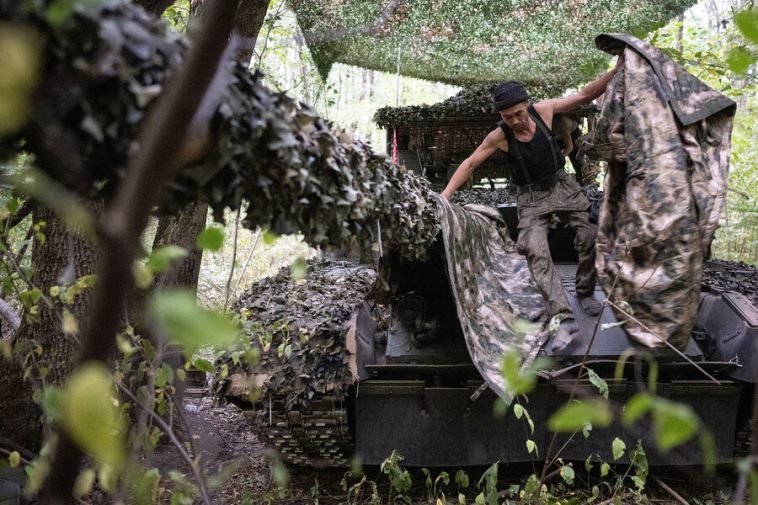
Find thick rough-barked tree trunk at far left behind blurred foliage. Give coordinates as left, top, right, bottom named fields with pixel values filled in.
left=0, top=204, right=99, bottom=450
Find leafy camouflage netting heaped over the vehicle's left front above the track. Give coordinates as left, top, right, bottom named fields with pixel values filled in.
left=224, top=260, right=376, bottom=405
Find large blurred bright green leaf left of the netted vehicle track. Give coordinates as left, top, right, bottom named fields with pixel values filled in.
left=149, top=291, right=239, bottom=355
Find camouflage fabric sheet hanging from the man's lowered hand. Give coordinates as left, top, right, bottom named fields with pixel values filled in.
left=437, top=198, right=547, bottom=402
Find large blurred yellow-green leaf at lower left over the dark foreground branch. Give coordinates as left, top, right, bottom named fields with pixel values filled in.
left=61, top=361, right=126, bottom=474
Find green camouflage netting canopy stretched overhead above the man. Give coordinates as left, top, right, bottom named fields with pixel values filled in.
left=290, top=0, right=695, bottom=88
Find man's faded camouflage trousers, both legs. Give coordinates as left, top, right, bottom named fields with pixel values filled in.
left=516, top=210, right=597, bottom=318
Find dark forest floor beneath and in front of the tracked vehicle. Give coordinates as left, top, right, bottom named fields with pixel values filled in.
left=145, top=397, right=736, bottom=505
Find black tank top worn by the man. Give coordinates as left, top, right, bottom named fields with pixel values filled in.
left=497, top=105, right=563, bottom=186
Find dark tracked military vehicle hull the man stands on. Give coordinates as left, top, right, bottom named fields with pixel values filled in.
left=226, top=191, right=758, bottom=466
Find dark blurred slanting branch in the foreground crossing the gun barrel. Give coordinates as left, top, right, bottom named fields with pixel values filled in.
left=43, top=0, right=237, bottom=505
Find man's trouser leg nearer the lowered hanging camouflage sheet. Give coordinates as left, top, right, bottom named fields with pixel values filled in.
left=516, top=214, right=573, bottom=318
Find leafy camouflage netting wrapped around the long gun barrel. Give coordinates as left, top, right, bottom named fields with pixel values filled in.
left=0, top=1, right=439, bottom=258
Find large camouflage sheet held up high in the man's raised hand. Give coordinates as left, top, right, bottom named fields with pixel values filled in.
left=590, top=34, right=735, bottom=348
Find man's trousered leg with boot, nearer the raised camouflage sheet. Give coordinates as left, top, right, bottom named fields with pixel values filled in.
left=560, top=211, right=602, bottom=316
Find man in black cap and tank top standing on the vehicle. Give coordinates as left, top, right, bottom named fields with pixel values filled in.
left=442, top=56, right=623, bottom=350
